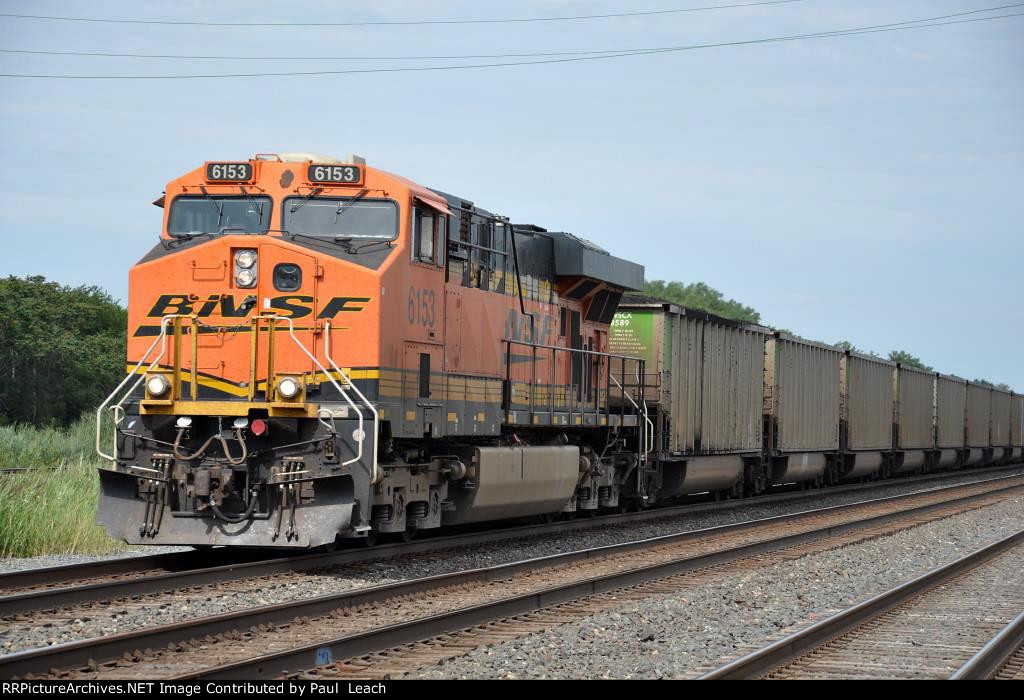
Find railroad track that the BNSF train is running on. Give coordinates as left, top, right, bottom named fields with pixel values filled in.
left=0, top=465, right=1020, bottom=620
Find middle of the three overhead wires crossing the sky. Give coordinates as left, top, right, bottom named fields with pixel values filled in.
left=0, top=2, right=1024, bottom=61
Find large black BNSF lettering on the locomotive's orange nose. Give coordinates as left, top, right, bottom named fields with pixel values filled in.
left=146, top=294, right=370, bottom=318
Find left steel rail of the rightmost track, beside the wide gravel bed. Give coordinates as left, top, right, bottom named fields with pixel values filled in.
left=700, top=530, right=1024, bottom=681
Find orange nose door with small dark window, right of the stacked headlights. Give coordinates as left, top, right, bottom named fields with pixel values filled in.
left=256, top=243, right=323, bottom=390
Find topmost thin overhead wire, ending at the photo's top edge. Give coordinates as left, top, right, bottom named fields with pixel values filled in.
left=0, top=0, right=805, bottom=27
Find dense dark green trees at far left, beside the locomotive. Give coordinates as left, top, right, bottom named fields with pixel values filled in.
left=0, top=276, right=127, bottom=426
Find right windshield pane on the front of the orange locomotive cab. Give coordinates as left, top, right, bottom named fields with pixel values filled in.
left=282, top=196, right=398, bottom=240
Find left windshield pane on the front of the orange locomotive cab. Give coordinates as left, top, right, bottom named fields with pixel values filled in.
left=167, top=194, right=270, bottom=236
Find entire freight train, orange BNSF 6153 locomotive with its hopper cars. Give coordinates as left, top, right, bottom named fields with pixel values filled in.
left=96, top=154, right=1024, bottom=548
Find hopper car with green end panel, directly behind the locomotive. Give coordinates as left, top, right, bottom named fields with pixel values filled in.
left=610, top=297, right=767, bottom=497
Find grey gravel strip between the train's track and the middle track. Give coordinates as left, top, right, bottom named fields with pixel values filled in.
left=0, top=469, right=1024, bottom=654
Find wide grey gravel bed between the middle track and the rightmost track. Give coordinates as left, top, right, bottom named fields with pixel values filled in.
left=407, top=496, right=1024, bottom=679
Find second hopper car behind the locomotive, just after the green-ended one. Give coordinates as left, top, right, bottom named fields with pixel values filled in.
left=764, top=333, right=843, bottom=483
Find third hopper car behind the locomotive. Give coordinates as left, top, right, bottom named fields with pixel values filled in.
left=839, top=352, right=896, bottom=479
